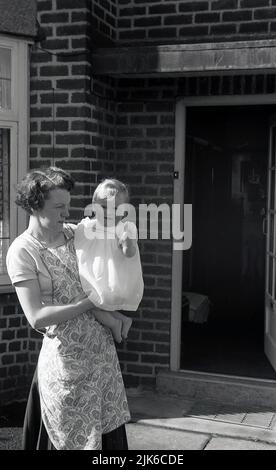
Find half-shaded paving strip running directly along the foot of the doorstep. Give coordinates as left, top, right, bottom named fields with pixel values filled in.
left=128, top=392, right=276, bottom=444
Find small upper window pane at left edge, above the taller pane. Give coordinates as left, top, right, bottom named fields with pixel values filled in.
left=0, top=47, right=11, bottom=109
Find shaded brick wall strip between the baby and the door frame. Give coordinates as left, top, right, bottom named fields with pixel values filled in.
left=116, top=79, right=177, bottom=387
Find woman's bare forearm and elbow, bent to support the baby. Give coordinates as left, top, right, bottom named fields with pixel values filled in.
left=14, top=279, right=93, bottom=328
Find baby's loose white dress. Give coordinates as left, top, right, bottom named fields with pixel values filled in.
left=75, top=217, right=144, bottom=311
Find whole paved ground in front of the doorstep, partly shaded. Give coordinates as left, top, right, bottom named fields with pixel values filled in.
left=0, top=389, right=276, bottom=451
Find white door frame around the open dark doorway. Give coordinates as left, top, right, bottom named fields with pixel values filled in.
left=170, top=93, right=276, bottom=371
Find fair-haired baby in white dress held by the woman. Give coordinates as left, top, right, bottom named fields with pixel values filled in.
left=75, top=179, right=144, bottom=343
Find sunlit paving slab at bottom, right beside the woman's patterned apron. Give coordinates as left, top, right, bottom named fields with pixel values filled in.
left=126, top=423, right=210, bottom=450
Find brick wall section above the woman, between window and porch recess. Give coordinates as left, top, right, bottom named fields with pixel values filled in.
left=30, top=0, right=115, bottom=220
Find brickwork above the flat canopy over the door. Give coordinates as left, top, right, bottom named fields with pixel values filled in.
left=117, top=0, right=276, bottom=44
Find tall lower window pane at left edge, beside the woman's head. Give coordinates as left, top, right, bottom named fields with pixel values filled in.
left=0, top=128, right=10, bottom=274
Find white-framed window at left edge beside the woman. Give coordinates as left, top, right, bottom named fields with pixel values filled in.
left=0, top=36, right=29, bottom=292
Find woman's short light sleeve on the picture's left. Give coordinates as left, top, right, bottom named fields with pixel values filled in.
left=6, top=243, right=37, bottom=284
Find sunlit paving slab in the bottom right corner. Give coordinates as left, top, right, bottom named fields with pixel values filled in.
left=204, top=437, right=276, bottom=450
